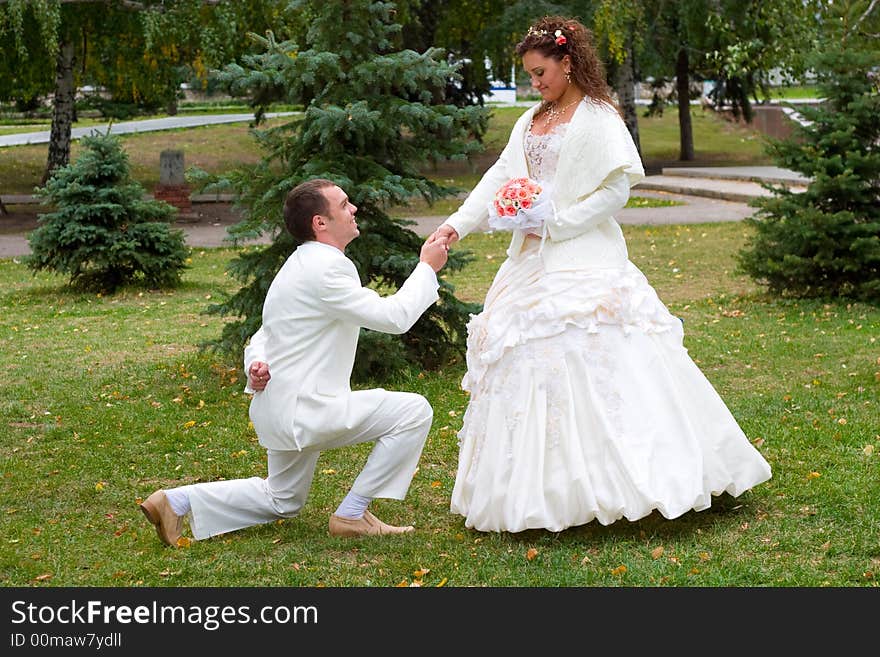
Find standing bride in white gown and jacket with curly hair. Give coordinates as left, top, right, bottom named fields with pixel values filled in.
left=435, top=17, right=771, bottom=532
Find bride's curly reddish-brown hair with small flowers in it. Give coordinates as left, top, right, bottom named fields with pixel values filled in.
left=516, top=16, right=619, bottom=114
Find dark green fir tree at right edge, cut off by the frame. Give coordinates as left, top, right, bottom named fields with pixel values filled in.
left=739, top=48, right=880, bottom=303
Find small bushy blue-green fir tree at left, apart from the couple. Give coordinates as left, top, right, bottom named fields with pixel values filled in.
left=25, top=133, right=189, bottom=292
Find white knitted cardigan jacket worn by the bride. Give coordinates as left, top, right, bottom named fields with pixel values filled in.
left=445, top=101, right=645, bottom=271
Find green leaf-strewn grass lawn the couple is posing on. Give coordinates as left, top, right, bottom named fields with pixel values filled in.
left=0, top=223, right=880, bottom=587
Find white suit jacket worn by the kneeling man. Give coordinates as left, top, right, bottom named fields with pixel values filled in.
left=245, top=241, right=439, bottom=450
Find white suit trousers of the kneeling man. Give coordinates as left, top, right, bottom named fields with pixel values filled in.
left=181, top=389, right=433, bottom=539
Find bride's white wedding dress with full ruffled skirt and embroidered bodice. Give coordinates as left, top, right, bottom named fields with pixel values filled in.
left=451, top=125, right=771, bottom=532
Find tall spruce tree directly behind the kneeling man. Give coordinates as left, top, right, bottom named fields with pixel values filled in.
left=200, top=0, right=487, bottom=379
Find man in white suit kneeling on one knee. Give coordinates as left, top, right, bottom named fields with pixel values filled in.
left=141, top=179, right=447, bottom=546
